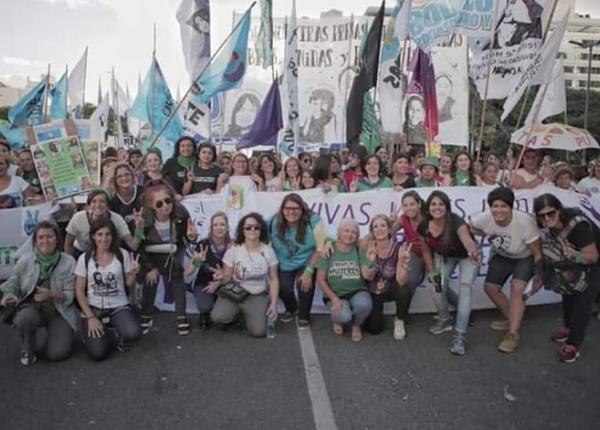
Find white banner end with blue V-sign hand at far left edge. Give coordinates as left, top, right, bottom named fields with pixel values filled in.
left=0, top=203, right=58, bottom=279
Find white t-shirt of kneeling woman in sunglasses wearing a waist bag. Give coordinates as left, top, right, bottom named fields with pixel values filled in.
left=223, top=244, right=277, bottom=294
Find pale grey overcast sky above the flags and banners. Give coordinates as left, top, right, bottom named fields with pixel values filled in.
left=0, top=0, right=600, bottom=103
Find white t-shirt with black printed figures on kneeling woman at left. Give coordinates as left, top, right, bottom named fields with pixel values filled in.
left=75, top=248, right=131, bottom=309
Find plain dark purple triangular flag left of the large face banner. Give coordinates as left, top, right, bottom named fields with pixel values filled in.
left=235, top=80, right=283, bottom=149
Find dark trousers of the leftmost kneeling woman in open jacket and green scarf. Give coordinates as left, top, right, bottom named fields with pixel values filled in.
left=14, top=306, right=73, bottom=361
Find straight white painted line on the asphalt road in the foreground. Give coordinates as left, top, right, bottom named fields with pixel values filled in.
left=298, top=328, right=337, bottom=430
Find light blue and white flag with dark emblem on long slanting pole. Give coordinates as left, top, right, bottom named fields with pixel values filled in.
left=196, top=10, right=250, bottom=103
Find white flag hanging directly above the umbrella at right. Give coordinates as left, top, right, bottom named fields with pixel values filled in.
left=525, top=59, right=567, bottom=124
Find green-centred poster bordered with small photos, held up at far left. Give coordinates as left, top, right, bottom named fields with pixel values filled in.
left=28, top=121, right=92, bottom=200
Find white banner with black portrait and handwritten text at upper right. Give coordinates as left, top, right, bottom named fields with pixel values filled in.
left=469, top=0, right=554, bottom=99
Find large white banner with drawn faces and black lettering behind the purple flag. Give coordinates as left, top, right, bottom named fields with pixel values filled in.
left=223, top=13, right=368, bottom=148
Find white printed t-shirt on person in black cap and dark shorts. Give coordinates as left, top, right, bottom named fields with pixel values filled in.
left=471, top=210, right=540, bottom=259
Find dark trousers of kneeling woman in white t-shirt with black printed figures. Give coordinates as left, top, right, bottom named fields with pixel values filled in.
left=82, top=306, right=142, bottom=361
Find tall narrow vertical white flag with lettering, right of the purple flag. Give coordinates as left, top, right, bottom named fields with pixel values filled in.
left=283, top=0, right=300, bottom=155
